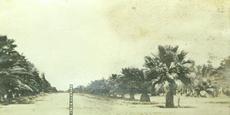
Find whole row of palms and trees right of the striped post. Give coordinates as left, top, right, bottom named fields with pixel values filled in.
left=75, top=45, right=230, bottom=107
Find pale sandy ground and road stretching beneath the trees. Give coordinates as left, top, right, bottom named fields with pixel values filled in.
left=0, top=93, right=230, bottom=115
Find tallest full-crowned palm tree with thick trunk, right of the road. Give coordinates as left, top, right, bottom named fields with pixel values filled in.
left=144, top=45, right=192, bottom=107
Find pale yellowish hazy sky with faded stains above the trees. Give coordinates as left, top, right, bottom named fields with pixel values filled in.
left=0, top=0, right=230, bottom=89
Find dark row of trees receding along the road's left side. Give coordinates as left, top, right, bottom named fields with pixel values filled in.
left=0, top=36, right=56, bottom=103
